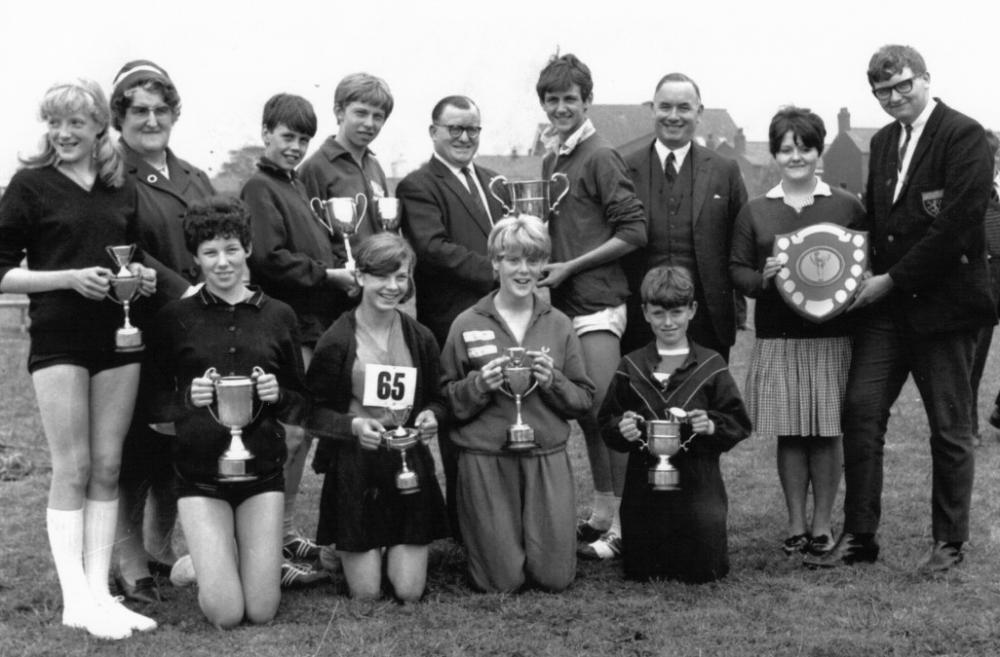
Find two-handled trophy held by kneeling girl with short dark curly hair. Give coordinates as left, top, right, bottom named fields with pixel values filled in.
left=205, top=367, right=264, bottom=481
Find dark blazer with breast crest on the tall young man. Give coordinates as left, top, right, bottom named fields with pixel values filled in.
left=866, top=101, right=996, bottom=334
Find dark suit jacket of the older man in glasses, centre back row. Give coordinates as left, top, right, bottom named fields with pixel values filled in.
left=396, top=157, right=504, bottom=345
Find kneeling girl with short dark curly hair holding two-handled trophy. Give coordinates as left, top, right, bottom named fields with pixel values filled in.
left=143, top=197, right=307, bottom=628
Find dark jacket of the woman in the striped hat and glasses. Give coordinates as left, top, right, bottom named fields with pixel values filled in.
left=121, top=140, right=215, bottom=306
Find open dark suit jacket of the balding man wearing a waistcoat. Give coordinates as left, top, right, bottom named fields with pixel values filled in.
left=622, top=142, right=747, bottom=345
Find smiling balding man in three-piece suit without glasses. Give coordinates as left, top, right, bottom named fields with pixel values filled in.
left=622, top=73, right=747, bottom=360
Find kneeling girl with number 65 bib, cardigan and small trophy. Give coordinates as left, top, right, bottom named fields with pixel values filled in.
left=306, top=233, right=448, bottom=602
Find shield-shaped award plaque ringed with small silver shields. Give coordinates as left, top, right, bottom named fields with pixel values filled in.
left=774, top=223, right=868, bottom=323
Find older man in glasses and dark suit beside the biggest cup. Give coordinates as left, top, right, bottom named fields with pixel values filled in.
left=396, top=96, right=503, bottom=345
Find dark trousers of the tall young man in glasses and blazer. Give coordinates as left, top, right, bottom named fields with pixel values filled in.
left=843, top=302, right=976, bottom=541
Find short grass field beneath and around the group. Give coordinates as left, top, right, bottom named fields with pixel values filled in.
left=0, top=322, right=1000, bottom=657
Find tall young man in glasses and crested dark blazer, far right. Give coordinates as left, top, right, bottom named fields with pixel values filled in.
left=806, top=45, right=996, bottom=572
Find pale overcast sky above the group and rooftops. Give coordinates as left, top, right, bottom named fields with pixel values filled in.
left=0, top=0, right=1000, bottom=184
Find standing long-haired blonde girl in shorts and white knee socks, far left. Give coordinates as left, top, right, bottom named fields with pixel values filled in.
left=0, top=80, right=156, bottom=639
